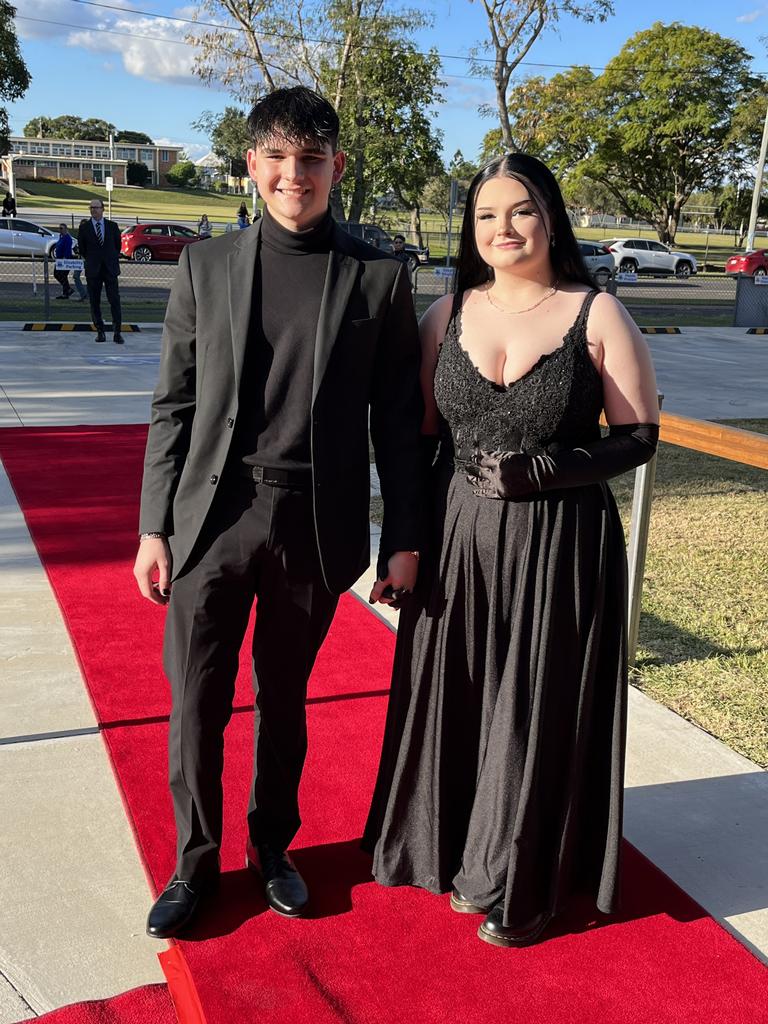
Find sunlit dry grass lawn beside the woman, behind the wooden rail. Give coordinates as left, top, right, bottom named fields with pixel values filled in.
left=372, top=420, right=768, bottom=767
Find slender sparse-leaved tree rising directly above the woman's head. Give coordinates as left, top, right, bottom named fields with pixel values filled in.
left=470, top=0, right=613, bottom=153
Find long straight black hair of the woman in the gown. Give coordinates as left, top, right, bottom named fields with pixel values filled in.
left=454, top=153, right=596, bottom=292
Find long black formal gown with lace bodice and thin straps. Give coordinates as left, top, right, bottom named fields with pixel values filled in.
left=364, top=293, right=627, bottom=926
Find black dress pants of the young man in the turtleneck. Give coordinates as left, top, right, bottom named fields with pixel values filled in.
left=164, top=479, right=338, bottom=881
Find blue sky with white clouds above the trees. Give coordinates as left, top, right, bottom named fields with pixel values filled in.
left=9, top=0, right=768, bottom=158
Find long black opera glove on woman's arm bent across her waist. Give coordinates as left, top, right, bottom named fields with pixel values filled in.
left=467, top=423, right=658, bottom=501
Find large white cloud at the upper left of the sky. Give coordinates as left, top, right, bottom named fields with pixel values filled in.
left=17, top=0, right=210, bottom=85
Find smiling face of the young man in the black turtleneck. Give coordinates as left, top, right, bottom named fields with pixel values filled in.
left=248, top=137, right=345, bottom=231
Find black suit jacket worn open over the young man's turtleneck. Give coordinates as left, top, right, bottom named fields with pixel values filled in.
left=139, top=222, right=424, bottom=594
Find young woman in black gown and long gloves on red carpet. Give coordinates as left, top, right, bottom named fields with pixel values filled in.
left=366, top=155, right=658, bottom=946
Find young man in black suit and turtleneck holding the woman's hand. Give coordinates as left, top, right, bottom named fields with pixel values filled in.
left=134, top=87, right=423, bottom=938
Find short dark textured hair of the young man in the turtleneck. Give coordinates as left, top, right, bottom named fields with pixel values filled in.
left=248, top=85, right=339, bottom=153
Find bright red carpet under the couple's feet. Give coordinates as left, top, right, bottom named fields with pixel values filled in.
left=0, top=417, right=768, bottom=1024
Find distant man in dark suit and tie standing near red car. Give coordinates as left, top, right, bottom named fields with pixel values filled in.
left=78, top=199, right=124, bottom=345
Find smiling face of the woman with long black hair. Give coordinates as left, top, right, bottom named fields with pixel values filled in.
left=474, top=176, right=551, bottom=275
